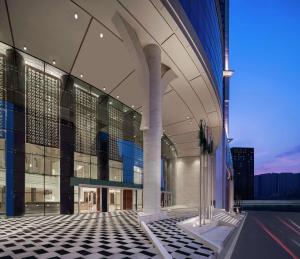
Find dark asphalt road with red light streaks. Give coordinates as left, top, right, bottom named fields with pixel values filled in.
left=231, top=211, right=300, bottom=259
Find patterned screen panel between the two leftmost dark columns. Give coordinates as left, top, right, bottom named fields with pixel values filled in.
left=26, top=65, right=60, bottom=147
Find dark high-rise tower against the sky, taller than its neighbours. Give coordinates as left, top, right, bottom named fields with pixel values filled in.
left=231, top=147, right=254, bottom=200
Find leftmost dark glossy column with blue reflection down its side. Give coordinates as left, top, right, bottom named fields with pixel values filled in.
left=5, top=49, right=25, bottom=216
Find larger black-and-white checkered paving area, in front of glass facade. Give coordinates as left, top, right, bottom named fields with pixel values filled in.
left=0, top=211, right=160, bottom=259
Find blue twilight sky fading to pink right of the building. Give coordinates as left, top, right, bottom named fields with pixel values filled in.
left=230, top=0, right=300, bottom=174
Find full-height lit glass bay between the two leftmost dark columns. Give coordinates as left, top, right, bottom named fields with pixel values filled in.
left=25, top=61, right=60, bottom=214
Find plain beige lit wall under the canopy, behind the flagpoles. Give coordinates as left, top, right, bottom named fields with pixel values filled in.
left=173, top=157, right=200, bottom=207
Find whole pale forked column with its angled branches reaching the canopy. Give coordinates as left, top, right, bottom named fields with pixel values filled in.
left=112, top=12, right=176, bottom=217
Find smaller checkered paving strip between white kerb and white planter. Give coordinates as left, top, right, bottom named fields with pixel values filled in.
left=148, top=215, right=214, bottom=259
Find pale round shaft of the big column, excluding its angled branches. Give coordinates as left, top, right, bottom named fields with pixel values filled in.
left=143, top=44, right=162, bottom=214
